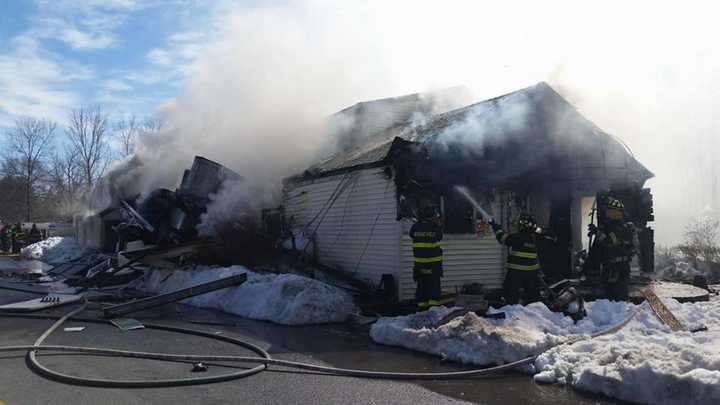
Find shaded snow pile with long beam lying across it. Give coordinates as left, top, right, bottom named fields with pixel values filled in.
left=139, top=266, right=358, bottom=325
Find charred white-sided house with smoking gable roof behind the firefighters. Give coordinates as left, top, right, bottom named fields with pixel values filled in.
left=283, top=83, right=653, bottom=300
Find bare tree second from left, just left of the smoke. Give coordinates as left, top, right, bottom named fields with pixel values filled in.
left=68, top=107, right=110, bottom=189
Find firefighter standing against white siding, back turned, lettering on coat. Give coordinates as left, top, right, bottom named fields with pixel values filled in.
left=410, top=206, right=443, bottom=309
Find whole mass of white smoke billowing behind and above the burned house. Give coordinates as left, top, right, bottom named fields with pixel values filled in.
left=100, top=0, right=720, bottom=243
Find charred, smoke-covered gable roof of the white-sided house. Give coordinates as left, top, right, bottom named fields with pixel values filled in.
left=301, top=82, right=653, bottom=191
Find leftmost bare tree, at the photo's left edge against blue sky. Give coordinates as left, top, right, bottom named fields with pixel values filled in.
left=5, top=117, right=57, bottom=222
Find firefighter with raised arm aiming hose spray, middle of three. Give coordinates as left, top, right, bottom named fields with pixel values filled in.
left=490, top=214, right=541, bottom=304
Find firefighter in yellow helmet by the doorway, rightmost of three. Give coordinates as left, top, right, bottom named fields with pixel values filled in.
left=588, top=197, right=635, bottom=301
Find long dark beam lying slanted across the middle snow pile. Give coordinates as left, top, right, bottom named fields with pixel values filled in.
left=103, top=273, right=247, bottom=318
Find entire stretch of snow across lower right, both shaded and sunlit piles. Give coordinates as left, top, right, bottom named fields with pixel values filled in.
left=370, top=299, right=720, bottom=404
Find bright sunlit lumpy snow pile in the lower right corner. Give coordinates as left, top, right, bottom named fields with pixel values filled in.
left=535, top=300, right=720, bottom=404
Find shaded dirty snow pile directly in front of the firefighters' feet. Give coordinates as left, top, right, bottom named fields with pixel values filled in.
left=370, top=300, right=631, bottom=365
